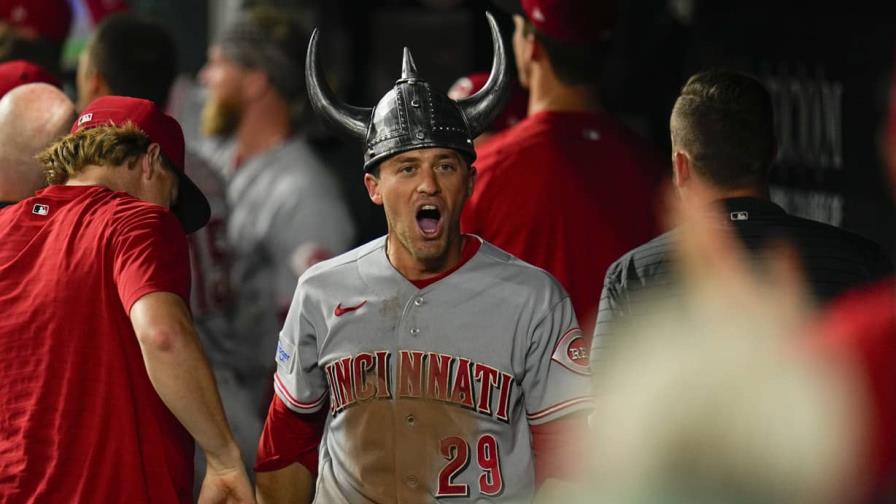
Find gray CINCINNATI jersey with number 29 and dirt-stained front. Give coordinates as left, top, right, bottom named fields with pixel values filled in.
left=274, top=237, right=591, bottom=503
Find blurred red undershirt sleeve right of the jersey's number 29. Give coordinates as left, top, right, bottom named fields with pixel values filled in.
left=529, top=413, right=588, bottom=488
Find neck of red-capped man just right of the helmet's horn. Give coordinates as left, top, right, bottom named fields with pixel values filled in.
left=529, top=68, right=601, bottom=116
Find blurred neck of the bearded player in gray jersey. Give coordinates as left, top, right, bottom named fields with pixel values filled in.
left=236, top=96, right=292, bottom=160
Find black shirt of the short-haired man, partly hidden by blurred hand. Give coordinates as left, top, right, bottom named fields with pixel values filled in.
left=592, top=198, right=892, bottom=357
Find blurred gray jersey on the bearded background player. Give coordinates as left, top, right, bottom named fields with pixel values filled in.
left=219, top=137, right=354, bottom=378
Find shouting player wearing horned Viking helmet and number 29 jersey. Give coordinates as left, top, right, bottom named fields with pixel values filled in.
left=256, top=16, right=590, bottom=503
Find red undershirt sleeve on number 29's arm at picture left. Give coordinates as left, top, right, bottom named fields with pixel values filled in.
left=255, top=395, right=327, bottom=478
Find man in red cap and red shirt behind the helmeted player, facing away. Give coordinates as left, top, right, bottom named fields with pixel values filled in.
left=462, top=0, right=667, bottom=339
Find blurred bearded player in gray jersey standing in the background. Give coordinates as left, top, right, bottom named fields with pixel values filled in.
left=200, top=5, right=355, bottom=428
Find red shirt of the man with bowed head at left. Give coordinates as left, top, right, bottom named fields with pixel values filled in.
left=0, top=186, right=193, bottom=503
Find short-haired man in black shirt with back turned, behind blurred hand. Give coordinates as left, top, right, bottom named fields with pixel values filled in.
left=593, top=70, right=892, bottom=359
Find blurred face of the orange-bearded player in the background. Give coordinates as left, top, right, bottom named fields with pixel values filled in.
left=199, top=46, right=245, bottom=136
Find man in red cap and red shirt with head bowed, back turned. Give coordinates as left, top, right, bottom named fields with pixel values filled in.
left=0, top=96, right=252, bottom=503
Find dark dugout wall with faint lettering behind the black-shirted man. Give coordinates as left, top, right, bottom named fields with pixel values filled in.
left=603, top=0, right=896, bottom=253
